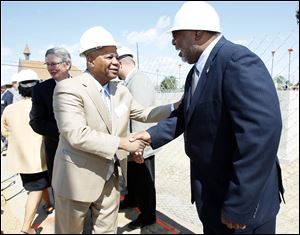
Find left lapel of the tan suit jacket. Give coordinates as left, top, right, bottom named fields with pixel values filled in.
left=82, top=73, right=112, bottom=133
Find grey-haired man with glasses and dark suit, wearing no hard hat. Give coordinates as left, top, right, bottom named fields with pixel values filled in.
left=30, top=47, right=72, bottom=182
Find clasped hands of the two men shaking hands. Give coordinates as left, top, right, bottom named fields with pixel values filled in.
left=119, top=131, right=151, bottom=163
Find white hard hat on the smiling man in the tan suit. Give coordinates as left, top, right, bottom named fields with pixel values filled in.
left=79, top=26, right=116, bottom=56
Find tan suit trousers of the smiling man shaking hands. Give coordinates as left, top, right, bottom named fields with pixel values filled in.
left=54, top=174, right=120, bottom=234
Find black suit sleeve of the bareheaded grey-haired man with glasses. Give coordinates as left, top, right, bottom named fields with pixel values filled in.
left=29, top=87, right=58, bottom=138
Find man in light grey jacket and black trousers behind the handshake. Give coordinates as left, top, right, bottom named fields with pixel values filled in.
left=117, top=46, right=156, bottom=229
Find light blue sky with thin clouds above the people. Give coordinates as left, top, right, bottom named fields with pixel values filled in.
left=1, top=1, right=299, bottom=85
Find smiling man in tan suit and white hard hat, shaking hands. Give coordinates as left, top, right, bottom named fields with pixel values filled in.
left=52, top=27, right=171, bottom=234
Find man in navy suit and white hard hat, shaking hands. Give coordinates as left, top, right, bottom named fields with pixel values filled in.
left=132, top=2, right=283, bottom=234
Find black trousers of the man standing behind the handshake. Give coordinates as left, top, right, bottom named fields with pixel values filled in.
left=124, top=155, right=156, bottom=221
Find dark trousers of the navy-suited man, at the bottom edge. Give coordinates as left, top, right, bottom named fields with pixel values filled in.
left=203, top=217, right=276, bottom=234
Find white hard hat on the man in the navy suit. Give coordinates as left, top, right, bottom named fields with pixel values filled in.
left=169, top=1, right=221, bottom=32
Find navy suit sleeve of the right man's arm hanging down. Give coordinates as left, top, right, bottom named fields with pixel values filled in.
left=222, top=49, right=282, bottom=224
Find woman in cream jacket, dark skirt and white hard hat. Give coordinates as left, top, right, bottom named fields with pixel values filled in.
left=1, top=69, right=53, bottom=234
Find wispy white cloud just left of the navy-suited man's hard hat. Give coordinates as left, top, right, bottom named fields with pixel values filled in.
left=127, top=16, right=171, bottom=49
